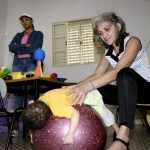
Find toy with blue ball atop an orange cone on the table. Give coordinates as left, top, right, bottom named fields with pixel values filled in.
left=34, top=48, right=45, bottom=77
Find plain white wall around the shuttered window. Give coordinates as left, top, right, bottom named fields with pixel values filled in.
left=0, top=0, right=150, bottom=82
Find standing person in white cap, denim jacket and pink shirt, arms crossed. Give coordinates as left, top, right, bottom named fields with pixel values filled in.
left=9, top=13, right=43, bottom=137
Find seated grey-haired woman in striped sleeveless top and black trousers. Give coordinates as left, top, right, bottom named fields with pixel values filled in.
left=68, top=12, right=150, bottom=150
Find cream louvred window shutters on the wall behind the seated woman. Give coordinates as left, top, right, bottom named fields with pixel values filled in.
left=53, top=19, right=104, bottom=67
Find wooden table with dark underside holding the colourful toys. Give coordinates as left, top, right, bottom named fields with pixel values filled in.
left=5, top=77, right=70, bottom=105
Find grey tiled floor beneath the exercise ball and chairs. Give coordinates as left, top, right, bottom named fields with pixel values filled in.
left=0, top=126, right=150, bottom=150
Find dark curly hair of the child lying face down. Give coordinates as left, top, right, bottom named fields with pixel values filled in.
left=22, top=100, right=51, bottom=130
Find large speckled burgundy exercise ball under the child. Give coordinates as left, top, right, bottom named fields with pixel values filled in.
left=33, top=105, right=107, bottom=150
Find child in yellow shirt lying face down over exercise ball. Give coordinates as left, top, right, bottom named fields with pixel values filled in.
left=22, top=88, right=118, bottom=144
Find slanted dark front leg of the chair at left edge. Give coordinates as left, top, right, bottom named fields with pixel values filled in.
left=5, top=112, right=16, bottom=150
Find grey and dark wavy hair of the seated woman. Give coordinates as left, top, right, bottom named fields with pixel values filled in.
left=93, top=12, right=129, bottom=47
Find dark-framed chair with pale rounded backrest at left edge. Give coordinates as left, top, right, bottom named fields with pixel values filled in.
left=0, top=78, right=25, bottom=150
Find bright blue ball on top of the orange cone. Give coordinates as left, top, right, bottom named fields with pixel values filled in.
left=34, top=48, right=45, bottom=61
